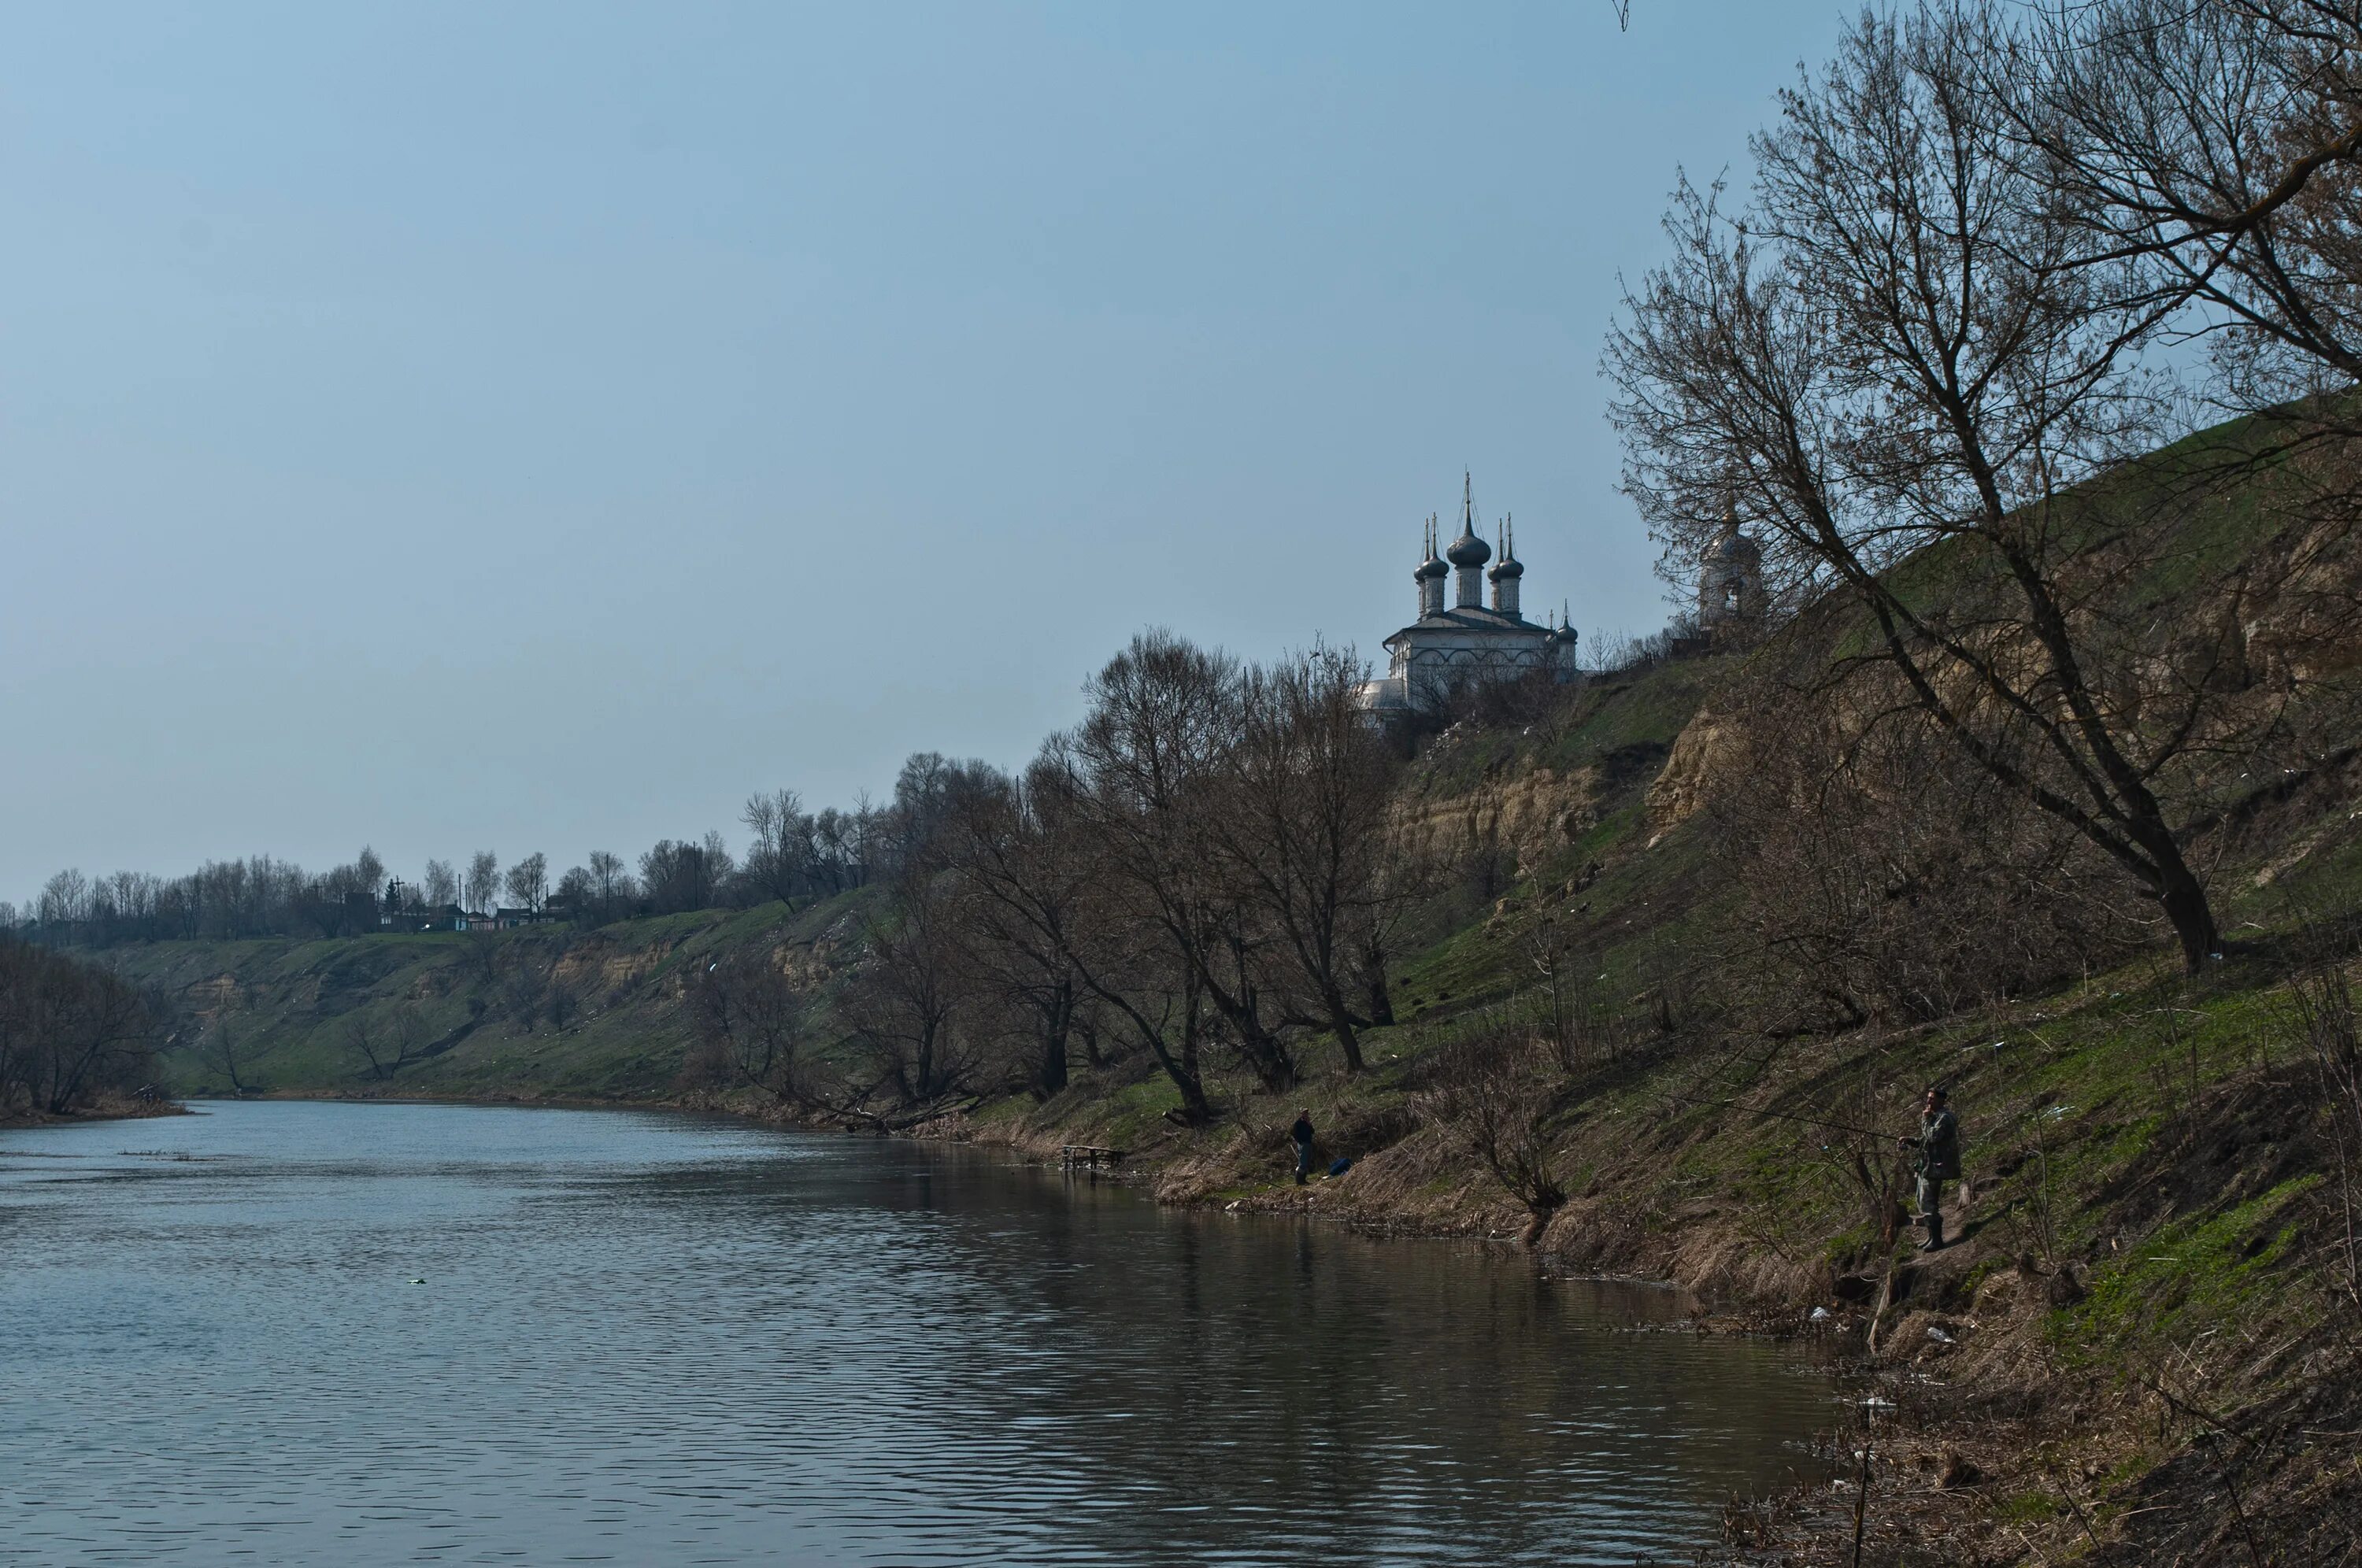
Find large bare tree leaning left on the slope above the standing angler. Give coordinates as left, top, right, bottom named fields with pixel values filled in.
left=1606, top=5, right=2220, bottom=968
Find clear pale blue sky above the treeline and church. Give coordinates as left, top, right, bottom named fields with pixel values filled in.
left=0, top=0, right=1845, bottom=897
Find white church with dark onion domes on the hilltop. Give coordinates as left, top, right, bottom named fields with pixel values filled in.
left=1361, top=475, right=1580, bottom=716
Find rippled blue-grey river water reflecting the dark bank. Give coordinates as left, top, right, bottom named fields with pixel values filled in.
left=0, top=1103, right=1831, bottom=1566
